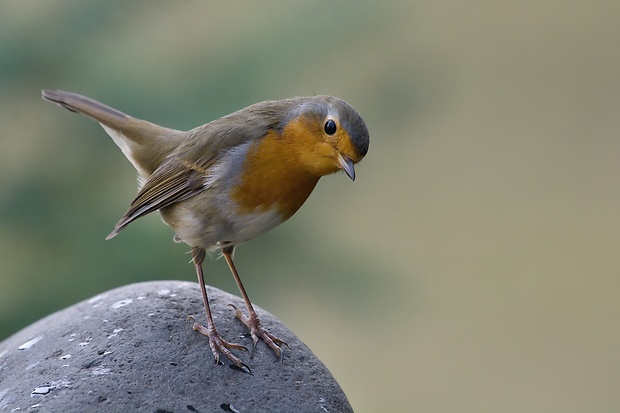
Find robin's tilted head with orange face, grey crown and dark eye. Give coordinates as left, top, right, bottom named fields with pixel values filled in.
left=282, top=96, right=369, bottom=180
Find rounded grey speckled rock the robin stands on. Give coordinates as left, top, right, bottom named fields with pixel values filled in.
left=0, top=281, right=352, bottom=413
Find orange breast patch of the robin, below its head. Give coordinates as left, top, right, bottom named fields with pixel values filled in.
left=231, top=125, right=320, bottom=219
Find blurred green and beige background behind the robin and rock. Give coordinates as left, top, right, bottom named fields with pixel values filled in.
left=0, top=0, right=620, bottom=412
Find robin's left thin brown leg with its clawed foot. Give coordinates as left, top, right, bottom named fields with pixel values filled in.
left=189, top=247, right=250, bottom=373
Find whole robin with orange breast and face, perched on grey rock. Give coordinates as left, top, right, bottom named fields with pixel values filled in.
left=42, top=90, right=369, bottom=372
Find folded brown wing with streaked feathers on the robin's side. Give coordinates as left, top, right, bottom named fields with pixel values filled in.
left=106, top=156, right=214, bottom=239
